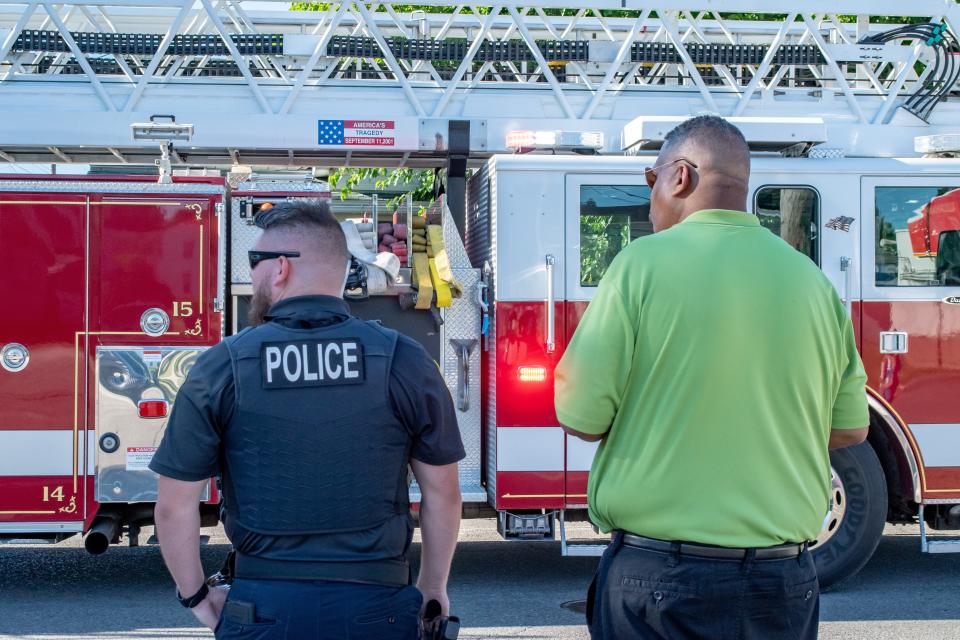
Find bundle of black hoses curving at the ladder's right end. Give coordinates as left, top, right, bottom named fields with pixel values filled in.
left=860, top=24, right=960, bottom=121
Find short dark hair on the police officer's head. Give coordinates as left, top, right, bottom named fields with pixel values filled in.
left=253, top=200, right=350, bottom=263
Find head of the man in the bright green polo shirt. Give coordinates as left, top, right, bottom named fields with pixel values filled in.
left=648, top=116, right=750, bottom=231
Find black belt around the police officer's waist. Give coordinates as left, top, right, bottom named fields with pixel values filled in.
left=234, top=553, right=410, bottom=587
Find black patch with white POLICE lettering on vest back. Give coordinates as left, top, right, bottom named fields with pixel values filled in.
left=260, top=340, right=364, bottom=389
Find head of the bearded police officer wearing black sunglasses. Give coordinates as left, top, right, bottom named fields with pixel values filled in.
left=251, top=200, right=350, bottom=303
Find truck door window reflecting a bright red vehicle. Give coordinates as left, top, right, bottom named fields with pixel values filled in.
left=874, top=187, right=960, bottom=287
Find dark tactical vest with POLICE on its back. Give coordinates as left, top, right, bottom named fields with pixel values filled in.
left=223, top=317, right=411, bottom=535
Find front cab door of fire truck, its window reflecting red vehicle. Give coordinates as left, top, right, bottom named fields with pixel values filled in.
left=861, top=175, right=960, bottom=499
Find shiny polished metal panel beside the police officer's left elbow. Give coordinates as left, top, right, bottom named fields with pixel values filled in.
left=95, top=346, right=210, bottom=503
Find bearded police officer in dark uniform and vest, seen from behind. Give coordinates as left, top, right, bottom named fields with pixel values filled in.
left=150, top=203, right=464, bottom=640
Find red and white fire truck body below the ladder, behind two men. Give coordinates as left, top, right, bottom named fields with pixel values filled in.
left=0, top=141, right=960, bottom=583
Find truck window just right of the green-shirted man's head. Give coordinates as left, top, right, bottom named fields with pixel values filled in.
left=753, top=186, right=820, bottom=262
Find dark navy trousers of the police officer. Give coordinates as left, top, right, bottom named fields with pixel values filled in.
left=214, top=579, right=423, bottom=640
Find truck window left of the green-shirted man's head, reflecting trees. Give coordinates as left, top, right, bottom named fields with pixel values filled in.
left=580, top=184, right=653, bottom=287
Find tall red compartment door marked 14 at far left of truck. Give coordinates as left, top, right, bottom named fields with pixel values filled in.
left=0, top=195, right=89, bottom=531
